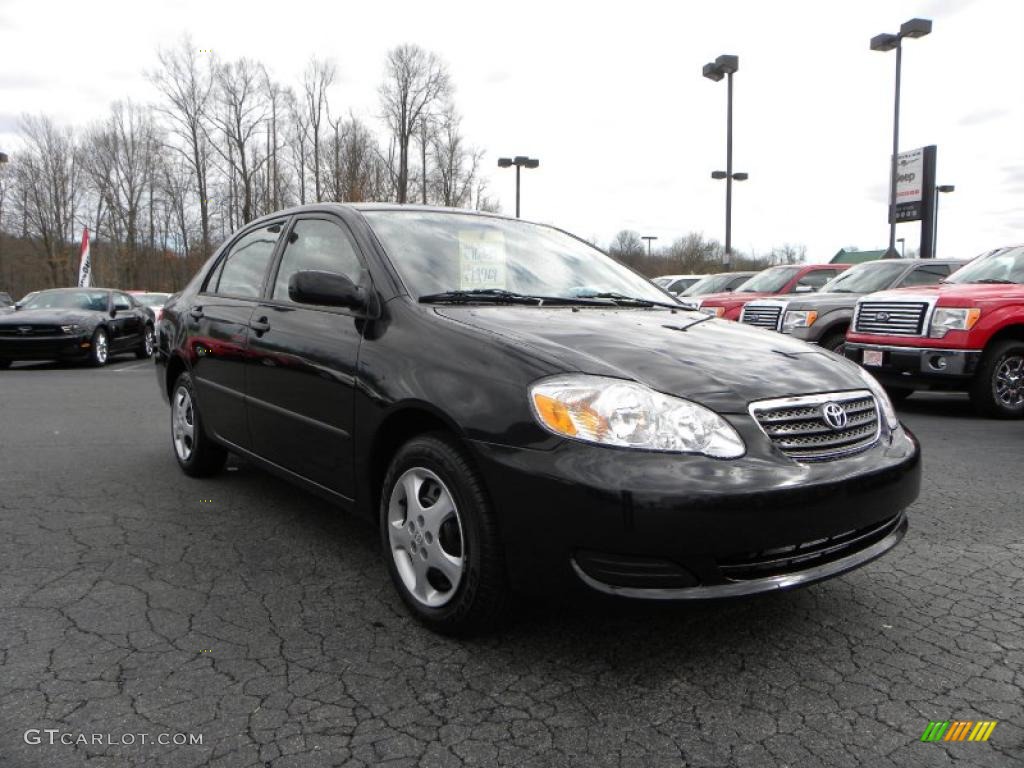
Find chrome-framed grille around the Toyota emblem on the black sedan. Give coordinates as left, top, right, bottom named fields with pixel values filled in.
left=751, top=389, right=880, bottom=461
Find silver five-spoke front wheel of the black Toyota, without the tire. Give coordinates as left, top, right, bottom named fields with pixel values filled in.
left=387, top=467, right=466, bottom=608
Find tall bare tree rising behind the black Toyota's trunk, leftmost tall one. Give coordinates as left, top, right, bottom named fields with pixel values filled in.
left=148, top=36, right=213, bottom=257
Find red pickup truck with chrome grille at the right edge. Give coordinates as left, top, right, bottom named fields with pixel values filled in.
left=845, top=246, right=1024, bottom=419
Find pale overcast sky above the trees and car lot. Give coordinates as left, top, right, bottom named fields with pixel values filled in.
left=0, top=0, right=1024, bottom=261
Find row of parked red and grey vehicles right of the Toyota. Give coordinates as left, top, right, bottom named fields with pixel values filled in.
left=663, top=247, right=1024, bottom=419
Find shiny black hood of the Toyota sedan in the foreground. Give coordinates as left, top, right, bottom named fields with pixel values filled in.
left=434, top=306, right=864, bottom=414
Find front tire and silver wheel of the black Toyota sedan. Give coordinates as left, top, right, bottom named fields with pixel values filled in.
left=380, top=433, right=509, bottom=635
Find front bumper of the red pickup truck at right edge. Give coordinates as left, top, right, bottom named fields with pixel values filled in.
left=844, top=341, right=982, bottom=389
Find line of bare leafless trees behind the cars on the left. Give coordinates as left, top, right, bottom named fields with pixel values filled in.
left=0, top=37, right=497, bottom=296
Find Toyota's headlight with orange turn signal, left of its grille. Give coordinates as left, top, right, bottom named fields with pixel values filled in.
left=529, top=374, right=746, bottom=459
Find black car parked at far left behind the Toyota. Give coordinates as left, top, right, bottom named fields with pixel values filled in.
left=0, top=288, right=155, bottom=369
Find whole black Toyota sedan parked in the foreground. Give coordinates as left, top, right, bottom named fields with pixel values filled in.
left=157, top=204, right=920, bottom=632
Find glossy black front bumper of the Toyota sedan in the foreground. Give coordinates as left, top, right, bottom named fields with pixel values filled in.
left=473, top=424, right=921, bottom=600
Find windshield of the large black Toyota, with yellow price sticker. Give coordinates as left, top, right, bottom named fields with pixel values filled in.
left=364, top=211, right=669, bottom=303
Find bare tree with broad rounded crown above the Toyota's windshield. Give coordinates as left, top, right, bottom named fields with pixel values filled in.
left=380, top=44, right=451, bottom=203
